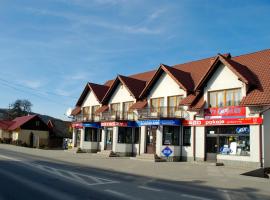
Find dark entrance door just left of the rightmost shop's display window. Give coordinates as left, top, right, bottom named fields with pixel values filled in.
left=206, top=136, right=218, bottom=162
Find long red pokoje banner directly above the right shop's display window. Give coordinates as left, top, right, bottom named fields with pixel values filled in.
left=182, top=117, right=263, bottom=126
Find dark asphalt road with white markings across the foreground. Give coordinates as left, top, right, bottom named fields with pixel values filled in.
left=0, top=149, right=270, bottom=200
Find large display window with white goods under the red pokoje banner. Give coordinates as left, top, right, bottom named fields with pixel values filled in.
left=206, top=125, right=250, bottom=156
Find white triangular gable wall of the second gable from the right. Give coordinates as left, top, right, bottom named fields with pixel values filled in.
left=147, top=72, right=186, bottom=106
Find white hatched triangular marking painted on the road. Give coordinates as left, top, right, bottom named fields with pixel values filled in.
left=33, top=165, right=119, bottom=186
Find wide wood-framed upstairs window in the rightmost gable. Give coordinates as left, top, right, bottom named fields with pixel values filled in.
left=208, top=89, right=242, bottom=107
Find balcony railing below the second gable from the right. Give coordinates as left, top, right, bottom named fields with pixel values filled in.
left=138, top=107, right=188, bottom=119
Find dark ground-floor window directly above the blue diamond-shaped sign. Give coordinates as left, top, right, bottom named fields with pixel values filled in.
left=163, top=126, right=180, bottom=146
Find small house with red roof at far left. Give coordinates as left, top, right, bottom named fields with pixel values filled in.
left=0, top=115, right=49, bottom=147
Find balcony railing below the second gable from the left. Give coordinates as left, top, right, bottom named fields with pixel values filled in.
left=101, top=111, right=136, bottom=121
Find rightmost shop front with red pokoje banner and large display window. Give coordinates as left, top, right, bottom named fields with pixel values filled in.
left=183, top=117, right=263, bottom=167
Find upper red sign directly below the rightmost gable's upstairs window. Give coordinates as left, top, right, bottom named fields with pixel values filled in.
left=204, top=106, right=246, bottom=119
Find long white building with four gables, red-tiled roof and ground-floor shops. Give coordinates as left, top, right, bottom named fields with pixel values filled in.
left=73, top=50, right=270, bottom=168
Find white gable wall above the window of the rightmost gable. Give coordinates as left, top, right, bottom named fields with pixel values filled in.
left=204, top=64, right=246, bottom=106
